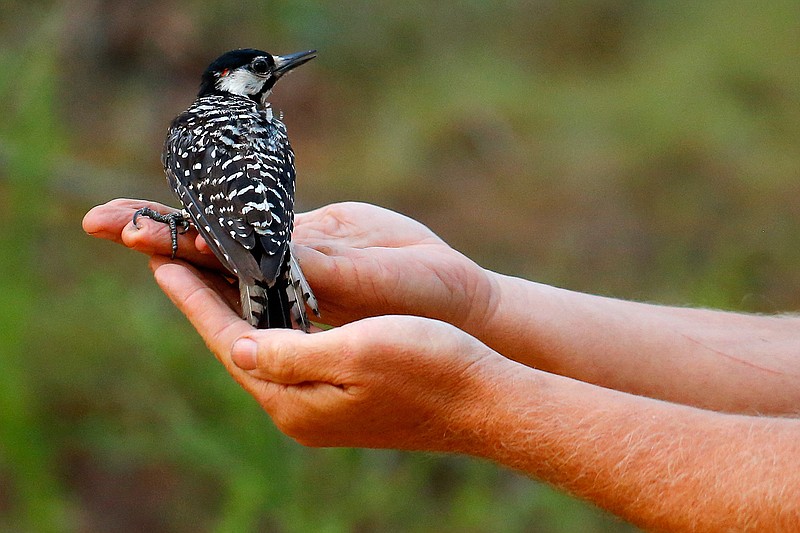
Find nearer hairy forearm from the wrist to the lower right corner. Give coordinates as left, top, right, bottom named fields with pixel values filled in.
left=464, top=369, right=800, bottom=531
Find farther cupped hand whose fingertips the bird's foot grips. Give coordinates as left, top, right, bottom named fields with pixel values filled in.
left=83, top=199, right=496, bottom=332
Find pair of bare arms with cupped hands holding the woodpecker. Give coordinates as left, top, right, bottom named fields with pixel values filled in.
left=84, top=200, right=800, bottom=531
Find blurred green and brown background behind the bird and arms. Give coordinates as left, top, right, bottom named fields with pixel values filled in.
left=0, top=0, right=800, bottom=532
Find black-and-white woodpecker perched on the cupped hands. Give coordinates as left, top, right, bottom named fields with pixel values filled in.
left=133, top=48, right=319, bottom=333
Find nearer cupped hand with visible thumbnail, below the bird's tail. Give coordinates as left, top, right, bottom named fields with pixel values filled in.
left=151, top=256, right=516, bottom=453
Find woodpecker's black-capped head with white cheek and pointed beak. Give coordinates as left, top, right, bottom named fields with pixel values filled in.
left=197, top=48, right=317, bottom=104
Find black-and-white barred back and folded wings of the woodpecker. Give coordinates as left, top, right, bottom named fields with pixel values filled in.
left=163, top=96, right=295, bottom=286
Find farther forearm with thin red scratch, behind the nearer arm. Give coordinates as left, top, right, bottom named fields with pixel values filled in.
left=471, top=274, right=800, bottom=414
